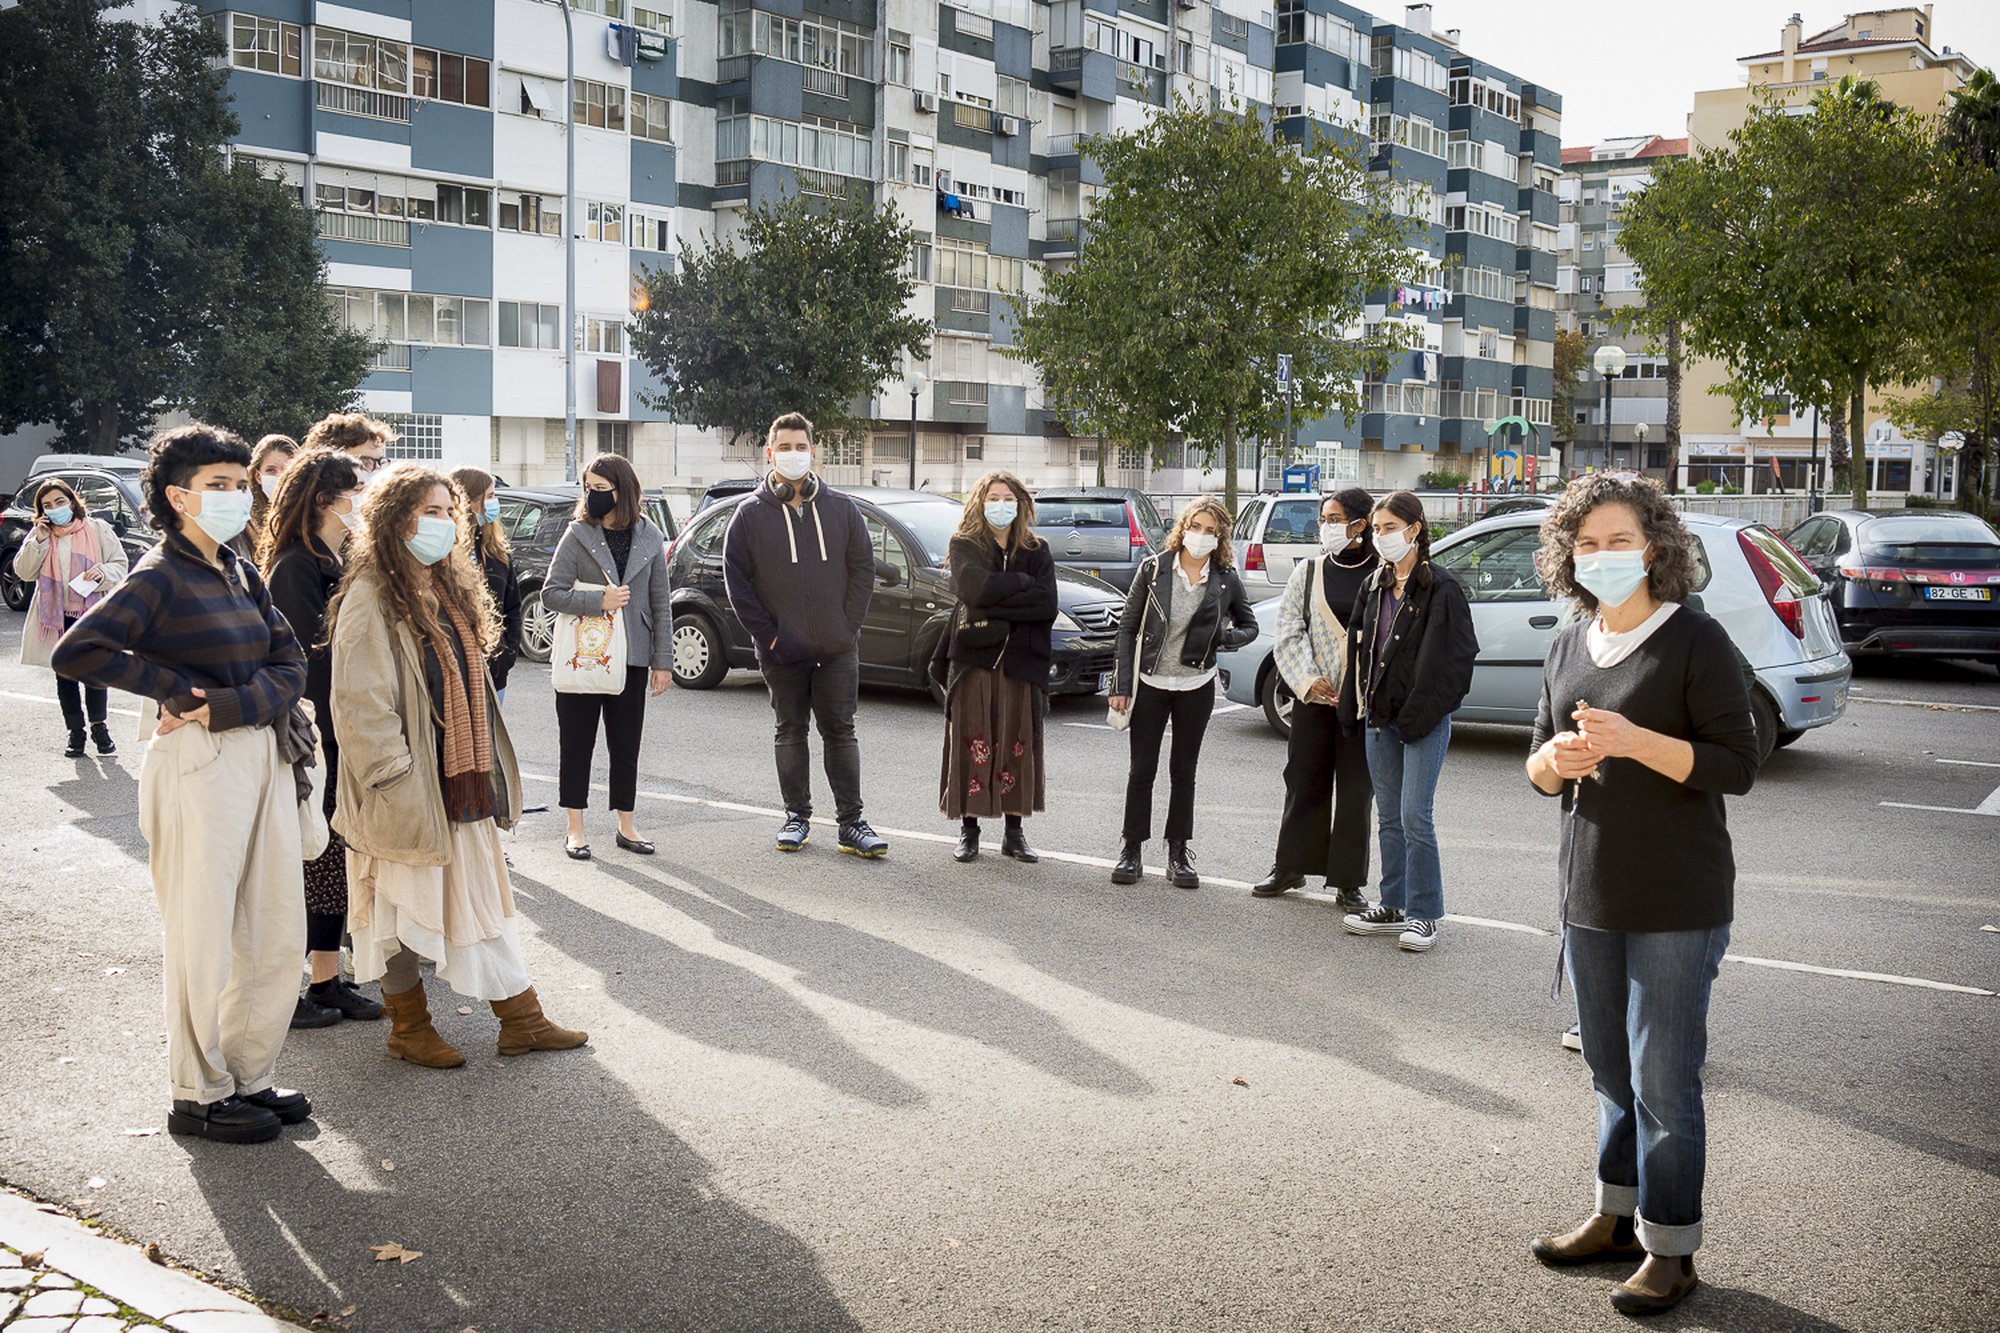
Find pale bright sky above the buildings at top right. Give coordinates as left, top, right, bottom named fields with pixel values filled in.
left=1348, top=0, right=2000, bottom=144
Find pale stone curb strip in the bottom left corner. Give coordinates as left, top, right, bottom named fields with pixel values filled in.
left=0, top=1189, right=308, bottom=1333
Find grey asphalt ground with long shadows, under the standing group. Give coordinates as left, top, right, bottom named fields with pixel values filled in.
left=0, top=614, right=2000, bottom=1333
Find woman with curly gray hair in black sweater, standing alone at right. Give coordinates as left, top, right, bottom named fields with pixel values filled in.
left=1528, top=476, right=1758, bottom=1315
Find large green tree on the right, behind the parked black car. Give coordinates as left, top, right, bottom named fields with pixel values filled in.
left=1620, top=78, right=1940, bottom=504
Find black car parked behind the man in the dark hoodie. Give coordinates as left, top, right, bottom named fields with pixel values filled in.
left=668, top=486, right=1124, bottom=695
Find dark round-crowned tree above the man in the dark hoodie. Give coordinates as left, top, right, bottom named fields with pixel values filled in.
left=632, top=196, right=930, bottom=444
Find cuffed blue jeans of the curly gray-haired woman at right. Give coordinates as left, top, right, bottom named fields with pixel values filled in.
left=1564, top=925, right=1730, bottom=1255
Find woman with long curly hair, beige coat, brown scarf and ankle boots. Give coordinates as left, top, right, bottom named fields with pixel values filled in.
left=328, top=464, right=588, bottom=1069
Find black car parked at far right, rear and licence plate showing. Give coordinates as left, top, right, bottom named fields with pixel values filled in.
left=1788, top=508, right=2000, bottom=664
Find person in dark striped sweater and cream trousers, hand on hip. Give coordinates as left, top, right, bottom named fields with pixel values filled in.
left=54, top=424, right=312, bottom=1143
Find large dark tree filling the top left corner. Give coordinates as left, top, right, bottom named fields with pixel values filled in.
left=0, top=0, right=370, bottom=452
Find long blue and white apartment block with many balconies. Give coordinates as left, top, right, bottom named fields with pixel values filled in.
left=200, top=0, right=1562, bottom=492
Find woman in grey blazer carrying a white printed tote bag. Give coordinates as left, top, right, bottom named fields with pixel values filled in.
left=542, top=454, right=674, bottom=861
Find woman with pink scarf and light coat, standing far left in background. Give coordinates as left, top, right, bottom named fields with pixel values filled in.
left=14, top=476, right=128, bottom=759
